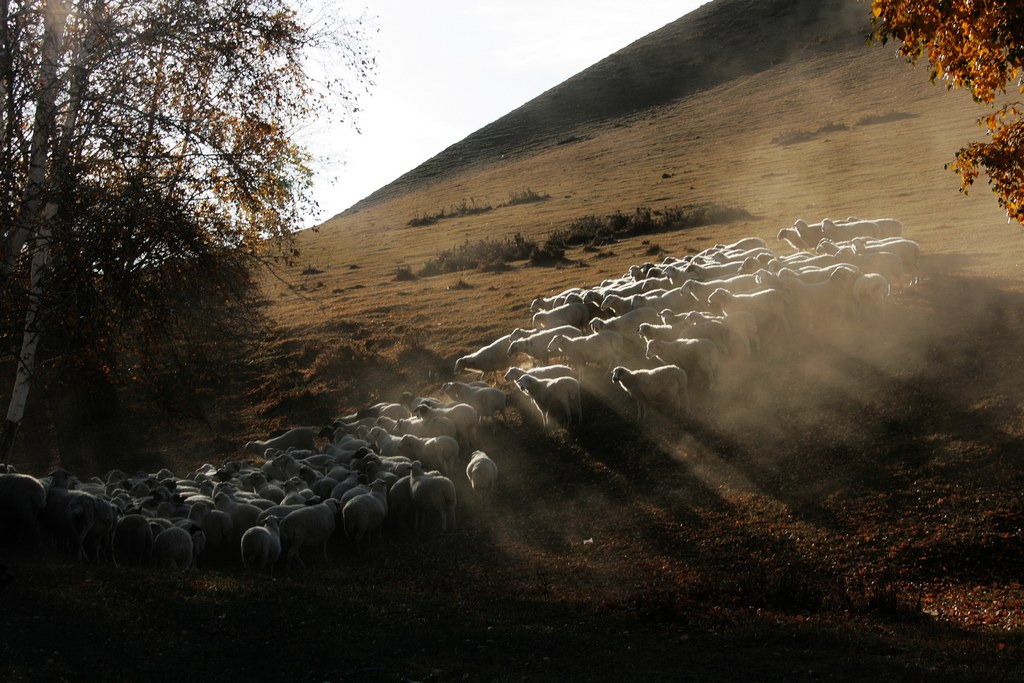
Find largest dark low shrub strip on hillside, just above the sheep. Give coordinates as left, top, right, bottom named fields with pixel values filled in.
left=544, top=204, right=751, bottom=257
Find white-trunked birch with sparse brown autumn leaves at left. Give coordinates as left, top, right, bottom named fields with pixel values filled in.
left=0, top=0, right=374, bottom=462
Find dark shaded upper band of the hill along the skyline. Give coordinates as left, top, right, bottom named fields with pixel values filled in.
left=353, top=0, right=867, bottom=209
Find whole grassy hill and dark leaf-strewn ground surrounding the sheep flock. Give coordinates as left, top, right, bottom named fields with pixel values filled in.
left=0, top=0, right=1024, bottom=681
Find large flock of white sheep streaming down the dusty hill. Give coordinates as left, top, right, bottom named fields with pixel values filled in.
left=0, top=218, right=919, bottom=572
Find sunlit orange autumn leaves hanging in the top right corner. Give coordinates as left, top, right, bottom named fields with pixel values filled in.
left=871, top=0, right=1024, bottom=223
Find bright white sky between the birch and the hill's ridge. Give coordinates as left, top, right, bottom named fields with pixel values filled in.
left=310, top=0, right=708, bottom=224
